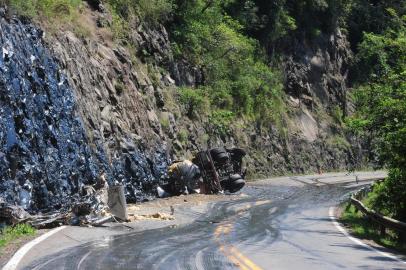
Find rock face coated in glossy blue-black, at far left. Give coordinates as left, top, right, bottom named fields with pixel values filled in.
left=0, top=17, right=98, bottom=210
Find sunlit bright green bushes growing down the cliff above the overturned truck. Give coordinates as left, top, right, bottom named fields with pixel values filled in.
left=171, top=0, right=283, bottom=129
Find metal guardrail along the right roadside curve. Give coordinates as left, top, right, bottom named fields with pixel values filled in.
left=350, top=188, right=406, bottom=235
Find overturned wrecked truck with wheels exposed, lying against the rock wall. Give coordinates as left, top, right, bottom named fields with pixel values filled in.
left=157, top=148, right=246, bottom=197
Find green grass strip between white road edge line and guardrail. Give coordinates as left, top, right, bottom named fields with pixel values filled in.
left=340, top=204, right=406, bottom=254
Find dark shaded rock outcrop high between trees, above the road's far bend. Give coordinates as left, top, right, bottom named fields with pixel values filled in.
left=285, top=29, right=351, bottom=114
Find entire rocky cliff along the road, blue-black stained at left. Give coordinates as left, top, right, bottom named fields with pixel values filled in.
left=0, top=3, right=362, bottom=211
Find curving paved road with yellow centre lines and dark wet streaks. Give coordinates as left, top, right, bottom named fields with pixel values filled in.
left=22, top=173, right=406, bottom=270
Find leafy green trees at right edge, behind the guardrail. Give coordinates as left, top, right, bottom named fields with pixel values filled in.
left=350, top=9, right=406, bottom=221
